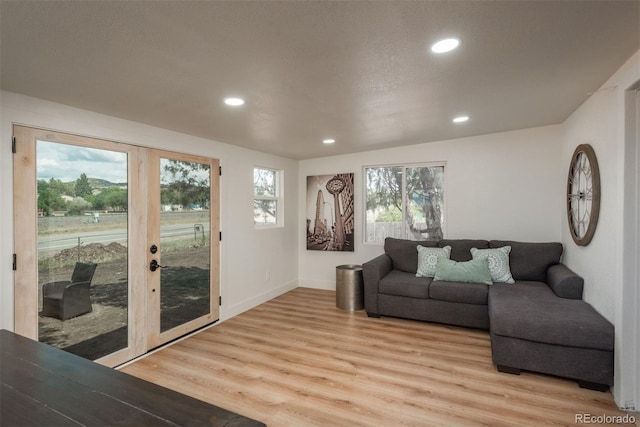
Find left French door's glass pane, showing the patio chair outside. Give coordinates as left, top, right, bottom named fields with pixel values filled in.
left=36, top=139, right=129, bottom=360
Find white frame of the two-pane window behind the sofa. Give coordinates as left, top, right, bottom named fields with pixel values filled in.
left=362, top=161, right=448, bottom=246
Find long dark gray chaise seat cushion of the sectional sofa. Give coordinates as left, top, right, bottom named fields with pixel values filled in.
left=489, top=281, right=614, bottom=351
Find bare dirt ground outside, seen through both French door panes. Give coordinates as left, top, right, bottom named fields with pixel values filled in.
left=38, top=243, right=209, bottom=360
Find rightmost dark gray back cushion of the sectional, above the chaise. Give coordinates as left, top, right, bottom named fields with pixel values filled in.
left=489, top=240, right=562, bottom=282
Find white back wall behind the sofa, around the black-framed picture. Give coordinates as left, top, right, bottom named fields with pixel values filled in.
left=298, top=126, right=564, bottom=289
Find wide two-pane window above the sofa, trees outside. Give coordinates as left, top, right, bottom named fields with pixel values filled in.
left=364, top=163, right=445, bottom=243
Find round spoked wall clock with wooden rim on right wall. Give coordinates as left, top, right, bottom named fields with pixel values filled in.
left=567, top=144, right=600, bottom=246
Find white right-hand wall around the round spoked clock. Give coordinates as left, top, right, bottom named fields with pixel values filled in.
left=562, top=52, right=640, bottom=410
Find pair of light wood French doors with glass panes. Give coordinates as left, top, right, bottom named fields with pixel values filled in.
left=14, top=126, right=219, bottom=366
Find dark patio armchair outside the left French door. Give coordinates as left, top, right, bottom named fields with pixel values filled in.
left=41, top=262, right=98, bottom=320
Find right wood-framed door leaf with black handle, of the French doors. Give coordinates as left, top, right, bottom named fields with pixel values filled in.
left=147, top=154, right=220, bottom=348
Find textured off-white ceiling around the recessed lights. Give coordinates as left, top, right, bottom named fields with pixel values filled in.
left=0, top=0, right=640, bottom=159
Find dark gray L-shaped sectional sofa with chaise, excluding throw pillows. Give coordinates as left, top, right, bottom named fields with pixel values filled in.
left=362, top=238, right=614, bottom=391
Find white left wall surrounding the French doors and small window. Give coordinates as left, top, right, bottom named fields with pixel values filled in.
left=0, top=92, right=298, bottom=330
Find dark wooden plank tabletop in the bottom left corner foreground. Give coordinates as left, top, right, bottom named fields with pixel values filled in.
left=0, top=330, right=264, bottom=427
